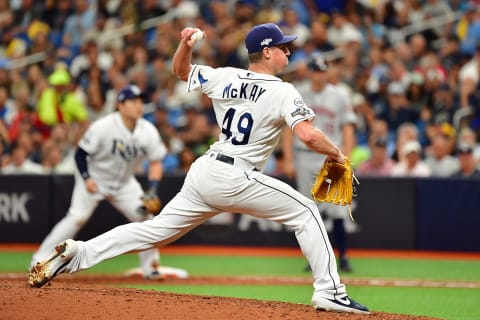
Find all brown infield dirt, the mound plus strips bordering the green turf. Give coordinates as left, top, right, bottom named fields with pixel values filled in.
left=0, top=245, right=480, bottom=320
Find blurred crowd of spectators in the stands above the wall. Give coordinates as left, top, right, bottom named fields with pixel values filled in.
left=0, top=0, right=480, bottom=177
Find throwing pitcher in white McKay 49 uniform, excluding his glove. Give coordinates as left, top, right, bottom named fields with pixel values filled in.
left=29, top=24, right=368, bottom=313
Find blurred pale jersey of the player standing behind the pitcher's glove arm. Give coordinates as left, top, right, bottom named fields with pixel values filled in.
left=295, top=84, right=356, bottom=150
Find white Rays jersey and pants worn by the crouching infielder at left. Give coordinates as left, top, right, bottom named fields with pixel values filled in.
left=31, top=112, right=167, bottom=275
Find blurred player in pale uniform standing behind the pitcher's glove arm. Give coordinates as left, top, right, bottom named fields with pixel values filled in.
left=283, top=55, right=356, bottom=271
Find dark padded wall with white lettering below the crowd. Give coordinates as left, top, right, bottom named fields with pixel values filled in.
left=0, top=175, right=480, bottom=252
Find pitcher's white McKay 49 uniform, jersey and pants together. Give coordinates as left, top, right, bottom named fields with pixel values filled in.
left=66, top=65, right=347, bottom=299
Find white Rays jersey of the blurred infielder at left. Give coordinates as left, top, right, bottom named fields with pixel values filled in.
left=79, top=112, right=167, bottom=189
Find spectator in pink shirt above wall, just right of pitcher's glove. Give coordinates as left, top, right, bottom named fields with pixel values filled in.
left=355, top=136, right=395, bottom=176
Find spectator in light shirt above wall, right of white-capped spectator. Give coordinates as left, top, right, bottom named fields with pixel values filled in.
left=425, top=135, right=459, bottom=177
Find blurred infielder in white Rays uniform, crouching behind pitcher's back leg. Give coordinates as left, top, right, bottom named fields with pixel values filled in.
left=31, top=85, right=186, bottom=279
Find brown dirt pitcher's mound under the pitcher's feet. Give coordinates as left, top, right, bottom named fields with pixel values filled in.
left=0, top=275, right=442, bottom=320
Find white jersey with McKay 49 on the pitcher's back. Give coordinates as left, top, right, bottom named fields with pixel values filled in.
left=187, top=65, right=314, bottom=170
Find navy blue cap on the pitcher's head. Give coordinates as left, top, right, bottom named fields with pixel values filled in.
left=245, top=23, right=297, bottom=54
